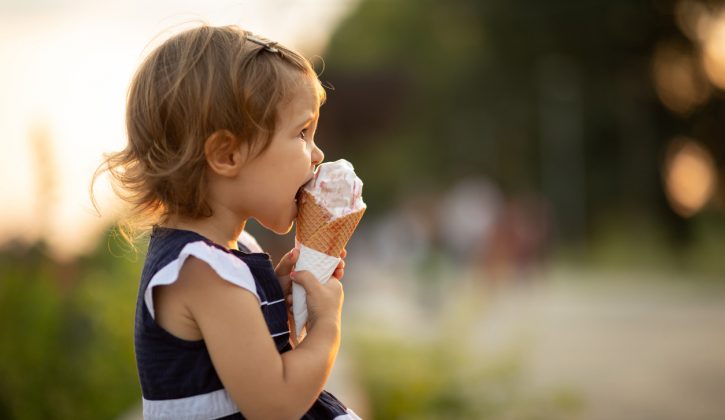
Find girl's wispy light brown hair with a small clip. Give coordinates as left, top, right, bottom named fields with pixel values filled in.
left=91, top=25, right=325, bottom=242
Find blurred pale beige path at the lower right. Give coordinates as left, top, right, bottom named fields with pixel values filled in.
left=475, top=271, right=725, bottom=420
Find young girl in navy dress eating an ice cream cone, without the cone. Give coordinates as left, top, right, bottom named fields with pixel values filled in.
left=93, top=26, right=358, bottom=419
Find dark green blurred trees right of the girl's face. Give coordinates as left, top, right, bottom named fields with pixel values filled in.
left=320, top=0, right=725, bottom=248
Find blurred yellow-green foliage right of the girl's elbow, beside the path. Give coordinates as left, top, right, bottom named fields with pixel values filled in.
left=348, top=316, right=582, bottom=420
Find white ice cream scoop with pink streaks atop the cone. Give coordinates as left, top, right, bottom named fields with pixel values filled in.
left=303, top=159, right=365, bottom=219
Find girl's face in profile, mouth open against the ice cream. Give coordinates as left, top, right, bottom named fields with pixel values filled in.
left=238, top=80, right=324, bottom=234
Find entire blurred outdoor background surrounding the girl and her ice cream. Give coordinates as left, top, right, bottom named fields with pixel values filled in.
left=0, top=0, right=725, bottom=420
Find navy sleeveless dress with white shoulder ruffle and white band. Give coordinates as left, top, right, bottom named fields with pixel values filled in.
left=134, top=226, right=359, bottom=420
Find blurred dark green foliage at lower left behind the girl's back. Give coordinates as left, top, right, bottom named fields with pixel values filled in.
left=0, top=234, right=140, bottom=419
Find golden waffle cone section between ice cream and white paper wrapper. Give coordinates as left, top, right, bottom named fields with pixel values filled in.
left=295, top=190, right=365, bottom=257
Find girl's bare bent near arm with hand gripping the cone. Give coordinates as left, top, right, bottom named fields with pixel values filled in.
left=168, top=258, right=343, bottom=419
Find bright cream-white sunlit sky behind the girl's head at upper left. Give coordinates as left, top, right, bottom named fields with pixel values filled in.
left=0, top=0, right=358, bottom=258
